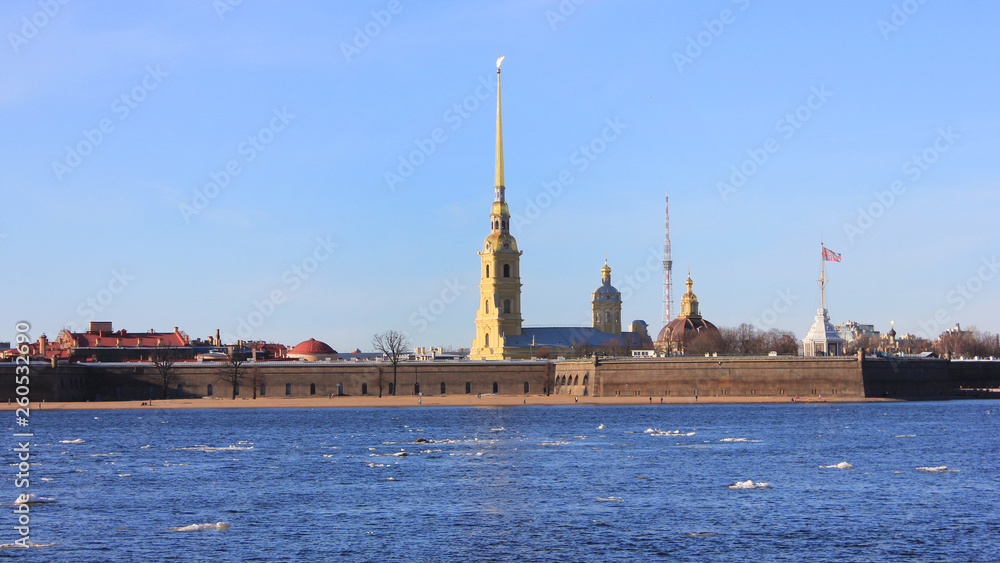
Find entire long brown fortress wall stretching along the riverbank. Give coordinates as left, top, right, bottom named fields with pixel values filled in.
left=0, top=357, right=1000, bottom=402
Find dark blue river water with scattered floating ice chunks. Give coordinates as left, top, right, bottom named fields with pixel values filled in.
left=7, top=401, right=1000, bottom=563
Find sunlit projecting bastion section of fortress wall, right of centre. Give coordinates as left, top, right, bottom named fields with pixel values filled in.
left=554, top=357, right=864, bottom=398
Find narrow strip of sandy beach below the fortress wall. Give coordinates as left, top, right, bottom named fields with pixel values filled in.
left=7, top=395, right=886, bottom=410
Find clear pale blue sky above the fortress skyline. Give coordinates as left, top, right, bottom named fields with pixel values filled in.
left=0, top=0, right=1000, bottom=351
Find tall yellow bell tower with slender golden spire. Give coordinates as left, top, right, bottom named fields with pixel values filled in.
left=469, top=57, right=521, bottom=360
